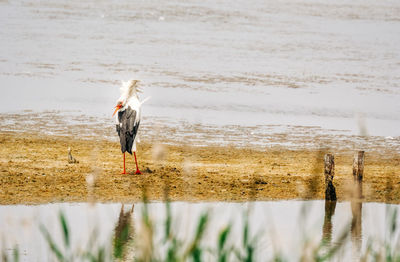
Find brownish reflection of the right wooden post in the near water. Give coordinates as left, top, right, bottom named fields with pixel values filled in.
left=350, top=199, right=362, bottom=259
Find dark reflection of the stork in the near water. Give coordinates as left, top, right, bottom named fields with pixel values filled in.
left=113, top=204, right=134, bottom=259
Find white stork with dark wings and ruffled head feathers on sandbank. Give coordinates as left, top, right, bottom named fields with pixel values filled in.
left=113, top=80, right=150, bottom=174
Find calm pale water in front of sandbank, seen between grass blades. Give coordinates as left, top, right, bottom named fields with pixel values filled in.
left=0, top=201, right=400, bottom=261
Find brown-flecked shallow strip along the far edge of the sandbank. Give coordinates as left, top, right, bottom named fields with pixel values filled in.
left=0, top=111, right=400, bottom=155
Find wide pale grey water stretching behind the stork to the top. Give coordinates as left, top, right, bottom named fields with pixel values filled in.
left=0, top=0, right=400, bottom=147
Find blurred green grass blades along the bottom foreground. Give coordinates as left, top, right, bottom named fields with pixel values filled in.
left=2, top=202, right=400, bottom=262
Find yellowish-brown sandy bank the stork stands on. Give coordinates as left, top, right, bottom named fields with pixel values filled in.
left=0, top=132, right=400, bottom=204
